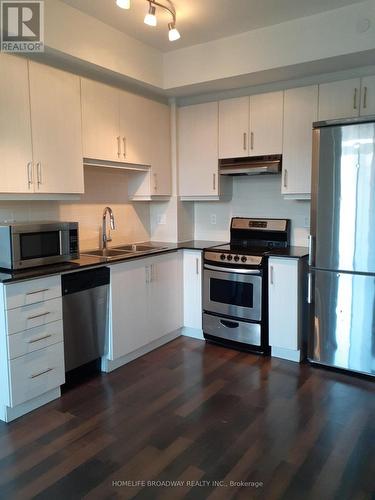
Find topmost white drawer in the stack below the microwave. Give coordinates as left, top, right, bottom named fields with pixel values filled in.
left=5, top=276, right=61, bottom=309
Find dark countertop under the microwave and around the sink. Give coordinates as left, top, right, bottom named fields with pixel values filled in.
left=0, top=240, right=223, bottom=283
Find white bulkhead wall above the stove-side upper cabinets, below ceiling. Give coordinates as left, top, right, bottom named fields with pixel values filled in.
left=163, top=0, right=375, bottom=89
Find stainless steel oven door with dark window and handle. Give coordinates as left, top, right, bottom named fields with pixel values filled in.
left=203, top=264, right=262, bottom=321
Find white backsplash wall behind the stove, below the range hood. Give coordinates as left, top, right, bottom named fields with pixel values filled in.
left=195, top=175, right=310, bottom=246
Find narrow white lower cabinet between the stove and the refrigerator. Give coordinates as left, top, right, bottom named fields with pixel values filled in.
left=268, top=257, right=307, bottom=361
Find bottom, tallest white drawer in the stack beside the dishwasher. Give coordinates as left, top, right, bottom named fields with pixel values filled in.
left=9, top=342, right=65, bottom=407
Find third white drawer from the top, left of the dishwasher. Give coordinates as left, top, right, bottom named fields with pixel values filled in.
left=8, top=321, right=64, bottom=359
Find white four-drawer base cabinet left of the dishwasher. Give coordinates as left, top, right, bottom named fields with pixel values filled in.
left=0, top=276, right=65, bottom=422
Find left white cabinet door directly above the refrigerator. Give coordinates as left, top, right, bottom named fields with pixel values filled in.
left=319, top=78, right=360, bottom=120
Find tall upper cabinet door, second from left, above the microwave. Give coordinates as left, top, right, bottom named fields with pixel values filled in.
left=29, top=61, right=84, bottom=193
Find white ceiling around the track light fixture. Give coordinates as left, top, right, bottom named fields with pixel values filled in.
left=62, top=0, right=362, bottom=52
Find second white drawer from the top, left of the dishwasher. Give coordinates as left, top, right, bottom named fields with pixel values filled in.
left=7, top=297, right=62, bottom=335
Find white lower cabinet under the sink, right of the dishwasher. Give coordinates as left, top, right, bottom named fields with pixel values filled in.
left=104, top=252, right=182, bottom=371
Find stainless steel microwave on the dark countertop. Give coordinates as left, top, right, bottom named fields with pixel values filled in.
left=0, top=222, right=79, bottom=269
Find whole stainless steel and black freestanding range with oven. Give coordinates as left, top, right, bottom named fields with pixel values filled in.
left=203, top=217, right=290, bottom=354
